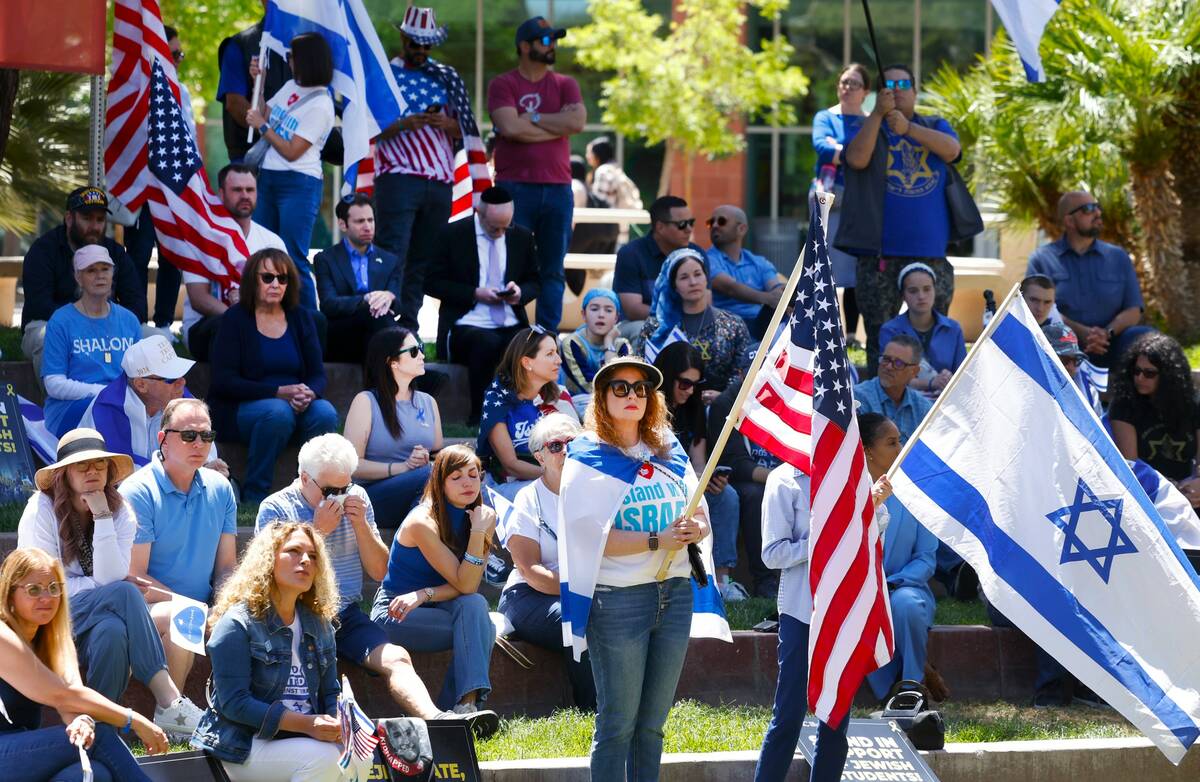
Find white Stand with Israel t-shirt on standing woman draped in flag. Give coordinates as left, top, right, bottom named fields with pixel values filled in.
left=596, top=462, right=691, bottom=587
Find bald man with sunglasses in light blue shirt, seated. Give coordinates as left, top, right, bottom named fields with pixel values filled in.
left=706, top=204, right=786, bottom=339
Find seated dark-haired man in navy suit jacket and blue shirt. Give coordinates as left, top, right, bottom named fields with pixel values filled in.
left=317, top=193, right=401, bottom=362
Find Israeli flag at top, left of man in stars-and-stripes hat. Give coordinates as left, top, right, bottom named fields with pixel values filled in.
left=263, top=0, right=408, bottom=196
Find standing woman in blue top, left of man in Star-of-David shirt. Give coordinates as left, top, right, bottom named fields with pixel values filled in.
left=812, top=62, right=871, bottom=335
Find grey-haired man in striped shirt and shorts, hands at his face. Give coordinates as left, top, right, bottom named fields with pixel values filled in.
left=254, top=433, right=499, bottom=735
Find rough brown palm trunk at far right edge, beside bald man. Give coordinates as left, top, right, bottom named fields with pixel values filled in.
left=1129, top=162, right=1200, bottom=343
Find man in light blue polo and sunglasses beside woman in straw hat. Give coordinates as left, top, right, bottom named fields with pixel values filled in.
left=118, top=398, right=238, bottom=691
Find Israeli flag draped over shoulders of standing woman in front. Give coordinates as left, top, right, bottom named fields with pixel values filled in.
left=558, top=432, right=733, bottom=660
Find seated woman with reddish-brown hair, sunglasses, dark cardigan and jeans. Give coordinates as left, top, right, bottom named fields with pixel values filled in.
left=209, top=249, right=337, bottom=505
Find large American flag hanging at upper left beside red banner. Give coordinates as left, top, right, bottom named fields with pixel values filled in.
left=104, top=0, right=250, bottom=288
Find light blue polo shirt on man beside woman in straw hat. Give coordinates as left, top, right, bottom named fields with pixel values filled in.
left=119, top=456, right=238, bottom=603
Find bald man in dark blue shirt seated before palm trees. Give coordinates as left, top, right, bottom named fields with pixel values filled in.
left=1025, top=191, right=1151, bottom=367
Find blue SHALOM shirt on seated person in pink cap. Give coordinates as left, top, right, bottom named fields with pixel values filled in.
left=42, top=302, right=142, bottom=437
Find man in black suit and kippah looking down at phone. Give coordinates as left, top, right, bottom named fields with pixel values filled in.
left=425, top=187, right=541, bottom=425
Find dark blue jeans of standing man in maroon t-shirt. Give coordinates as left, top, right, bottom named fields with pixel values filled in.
left=497, top=182, right=575, bottom=332
